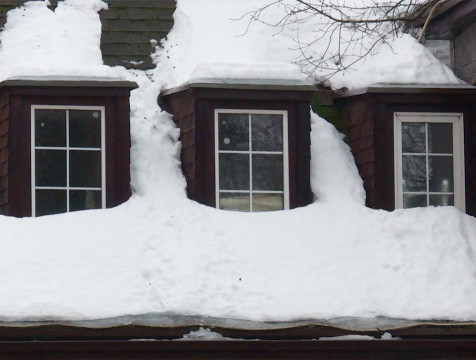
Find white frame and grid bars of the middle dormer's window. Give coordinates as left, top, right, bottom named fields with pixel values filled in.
left=215, top=109, right=289, bottom=212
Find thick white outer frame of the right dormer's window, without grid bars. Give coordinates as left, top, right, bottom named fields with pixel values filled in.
left=394, top=112, right=466, bottom=212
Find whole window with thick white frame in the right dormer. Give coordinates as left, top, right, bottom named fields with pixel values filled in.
left=394, top=112, right=465, bottom=212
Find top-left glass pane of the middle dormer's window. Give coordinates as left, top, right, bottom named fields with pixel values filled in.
left=218, top=114, right=249, bottom=151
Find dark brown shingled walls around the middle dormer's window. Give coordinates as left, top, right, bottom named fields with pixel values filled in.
left=159, top=84, right=314, bottom=208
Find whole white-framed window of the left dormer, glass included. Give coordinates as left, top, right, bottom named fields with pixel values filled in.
left=31, top=105, right=106, bottom=216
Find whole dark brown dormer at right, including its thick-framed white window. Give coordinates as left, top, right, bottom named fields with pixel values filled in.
left=334, top=84, right=476, bottom=216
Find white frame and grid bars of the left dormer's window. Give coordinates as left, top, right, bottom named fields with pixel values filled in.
left=31, top=105, right=106, bottom=217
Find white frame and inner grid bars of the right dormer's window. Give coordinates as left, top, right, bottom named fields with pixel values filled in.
left=394, top=113, right=465, bottom=212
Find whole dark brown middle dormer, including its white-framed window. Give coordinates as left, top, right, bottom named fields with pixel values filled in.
left=159, top=80, right=315, bottom=212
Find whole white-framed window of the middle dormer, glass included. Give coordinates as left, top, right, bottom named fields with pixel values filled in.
left=215, top=109, right=289, bottom=212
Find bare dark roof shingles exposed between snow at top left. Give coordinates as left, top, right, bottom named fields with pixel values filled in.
left=0, top=0, right=175, bottom=69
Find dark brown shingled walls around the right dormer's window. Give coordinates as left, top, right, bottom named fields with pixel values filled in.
left=334, top=86, right=476, bottom=216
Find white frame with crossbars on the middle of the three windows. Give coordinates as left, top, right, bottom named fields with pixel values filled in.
left=215, top=109, right=289, bottom=212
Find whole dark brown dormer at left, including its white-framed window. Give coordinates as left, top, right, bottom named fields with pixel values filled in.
left=0, top=78, right=137, bottom=217
